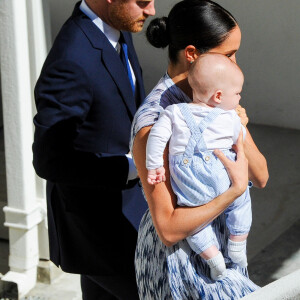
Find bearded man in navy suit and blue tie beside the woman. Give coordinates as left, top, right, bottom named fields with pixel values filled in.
left=33, top=0, right=155, bottom=300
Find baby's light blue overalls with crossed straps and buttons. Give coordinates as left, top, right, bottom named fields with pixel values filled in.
left=169, top=103, right=252, bottom=254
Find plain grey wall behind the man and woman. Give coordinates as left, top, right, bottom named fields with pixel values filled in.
left=50, top=0, right=300, bottom=129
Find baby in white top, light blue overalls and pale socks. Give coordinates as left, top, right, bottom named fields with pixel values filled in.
left=146, top=54, right=252, bottom=280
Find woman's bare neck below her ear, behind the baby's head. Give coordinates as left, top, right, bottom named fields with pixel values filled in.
left=168, top=63, right=193, bottom=99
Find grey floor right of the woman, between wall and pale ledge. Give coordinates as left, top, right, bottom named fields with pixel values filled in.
left=248, top=125, right=300, bottom=286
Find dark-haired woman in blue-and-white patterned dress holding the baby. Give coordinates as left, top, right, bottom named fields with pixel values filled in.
left=131, top=0, right=268, bottom=300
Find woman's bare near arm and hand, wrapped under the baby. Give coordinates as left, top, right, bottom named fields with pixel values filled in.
left=133, top=127, right=248, bottom=246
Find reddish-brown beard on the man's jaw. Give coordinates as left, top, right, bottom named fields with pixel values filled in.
left=109, top=3, right=146, bottom=32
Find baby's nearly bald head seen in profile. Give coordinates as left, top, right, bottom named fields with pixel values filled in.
left=188, top=53, right=244, bottom=110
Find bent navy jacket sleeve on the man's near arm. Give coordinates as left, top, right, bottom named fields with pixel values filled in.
left=33, top=61, right=128, bottom=188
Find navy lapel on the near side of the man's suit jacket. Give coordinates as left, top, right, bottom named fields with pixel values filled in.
left=73, top=3, right=136, bottom=117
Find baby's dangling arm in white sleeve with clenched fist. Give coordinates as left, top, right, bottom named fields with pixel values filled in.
left=146, top=108, right=172, bottom=184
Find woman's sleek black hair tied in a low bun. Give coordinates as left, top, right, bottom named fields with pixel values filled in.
left=146, top=0, right=237, bottom=63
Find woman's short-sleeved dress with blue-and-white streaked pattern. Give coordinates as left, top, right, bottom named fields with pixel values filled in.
left=131, top=74, right=258, bottom=300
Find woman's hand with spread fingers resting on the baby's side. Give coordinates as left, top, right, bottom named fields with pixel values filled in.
left=214, top=130, right=249, bottom=196
